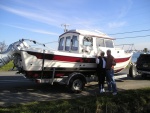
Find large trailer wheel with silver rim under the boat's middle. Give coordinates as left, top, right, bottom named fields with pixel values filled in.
left=69, top=78, right=85, bottom=93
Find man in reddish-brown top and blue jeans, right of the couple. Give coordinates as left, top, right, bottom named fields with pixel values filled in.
left=106, top=50, right=117, bottom=95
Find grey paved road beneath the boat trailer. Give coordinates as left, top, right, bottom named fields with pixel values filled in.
left=0, top=71, right=150, bottom=106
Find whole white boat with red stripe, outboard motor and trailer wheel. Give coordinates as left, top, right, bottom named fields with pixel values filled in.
left=0, top=30, right=133, bottom=92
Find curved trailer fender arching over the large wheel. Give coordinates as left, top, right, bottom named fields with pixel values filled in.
left=67, top=73, right=87, bottom=85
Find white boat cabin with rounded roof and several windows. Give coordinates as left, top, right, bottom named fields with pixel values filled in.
left=58, top=30, right=114, bottom=55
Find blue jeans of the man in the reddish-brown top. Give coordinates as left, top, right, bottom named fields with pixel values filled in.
left=106, top=69, right=117, bottom=92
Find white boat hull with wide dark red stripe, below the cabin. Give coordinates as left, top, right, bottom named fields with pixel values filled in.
left=21, top=51, right=132, bottom=78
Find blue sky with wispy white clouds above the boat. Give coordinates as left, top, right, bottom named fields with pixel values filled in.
left=0, top=0, right=150, bottom=50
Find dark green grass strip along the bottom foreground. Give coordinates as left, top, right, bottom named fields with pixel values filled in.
left=0, top=88, right=150, bottom=113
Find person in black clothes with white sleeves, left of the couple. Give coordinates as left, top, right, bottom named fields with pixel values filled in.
left=96, top=51, right=106, bottom=93
